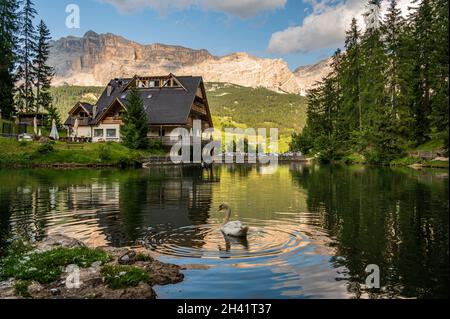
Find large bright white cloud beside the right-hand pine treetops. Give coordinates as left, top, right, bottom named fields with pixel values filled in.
left=268, top=0, right=412, bottom=54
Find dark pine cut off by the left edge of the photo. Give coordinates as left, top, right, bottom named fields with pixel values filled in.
left=0, top=0, right=18, bottom=119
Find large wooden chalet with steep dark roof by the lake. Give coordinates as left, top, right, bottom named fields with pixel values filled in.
left=64, top=74, right=213, bottom=145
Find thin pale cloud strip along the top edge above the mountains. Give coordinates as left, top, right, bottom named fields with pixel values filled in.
left=98, top=0, right=287, bottom=18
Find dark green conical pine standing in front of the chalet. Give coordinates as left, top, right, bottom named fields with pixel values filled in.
left=121, top=88, right=149, bottom=149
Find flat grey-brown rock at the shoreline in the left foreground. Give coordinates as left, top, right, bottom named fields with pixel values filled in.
left=0, top=235, right=184, bottom=299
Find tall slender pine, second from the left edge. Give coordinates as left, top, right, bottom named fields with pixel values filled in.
left=17, top=0, right=37, bottom=112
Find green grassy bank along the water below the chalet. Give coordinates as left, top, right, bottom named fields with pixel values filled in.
left=0, top=138, right=164, bottom=166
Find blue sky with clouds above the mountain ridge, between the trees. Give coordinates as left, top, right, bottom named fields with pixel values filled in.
left=35, top=0, right=414, bottom=69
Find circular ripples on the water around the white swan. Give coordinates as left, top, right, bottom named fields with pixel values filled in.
left=143, top=219, right=309, bottom=260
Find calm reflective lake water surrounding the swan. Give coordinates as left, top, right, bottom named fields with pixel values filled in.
left=0, top=164, right=449, bottom=298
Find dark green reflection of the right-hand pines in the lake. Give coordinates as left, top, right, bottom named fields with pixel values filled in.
left=292, top=166, right=449, bottom=297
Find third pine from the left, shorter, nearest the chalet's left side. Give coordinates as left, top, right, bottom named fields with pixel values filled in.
left=32, top=20, right=54, bottom=113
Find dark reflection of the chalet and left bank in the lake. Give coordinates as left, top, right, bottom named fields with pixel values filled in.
left=4, top=167, right=218, bottom=250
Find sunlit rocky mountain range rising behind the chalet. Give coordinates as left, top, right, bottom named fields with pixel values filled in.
left=49, top=31, right=330, bottom=95
